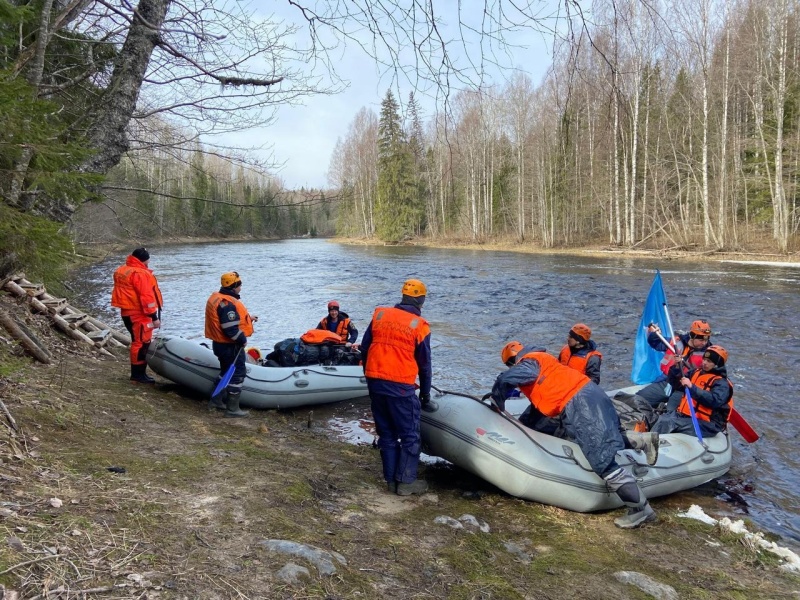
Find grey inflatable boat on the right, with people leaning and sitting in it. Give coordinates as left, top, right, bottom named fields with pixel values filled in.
left=421, top=390, right=731, bottom=512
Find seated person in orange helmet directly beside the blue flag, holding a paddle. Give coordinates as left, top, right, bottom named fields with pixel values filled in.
left=636, top=319, right=711, bottom=412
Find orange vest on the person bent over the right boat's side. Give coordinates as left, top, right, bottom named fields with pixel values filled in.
left=517, top=352, right=590, bottom=417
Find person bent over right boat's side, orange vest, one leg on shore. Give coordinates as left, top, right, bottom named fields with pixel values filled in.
left=491, top=341, right=656, bottom=529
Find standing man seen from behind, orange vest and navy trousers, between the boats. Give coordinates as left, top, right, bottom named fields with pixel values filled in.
left=361, top=279, right=431, bottom=496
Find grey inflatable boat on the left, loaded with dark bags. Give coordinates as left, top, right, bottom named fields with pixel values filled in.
left=147, top=336, right=367, bottom=408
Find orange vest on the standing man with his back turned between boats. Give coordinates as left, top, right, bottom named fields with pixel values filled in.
left=364, top=306, right=431, bottom=384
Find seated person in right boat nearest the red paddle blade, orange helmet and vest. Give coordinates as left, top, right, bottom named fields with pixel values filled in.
left=653, top=345, right=733, bottom=437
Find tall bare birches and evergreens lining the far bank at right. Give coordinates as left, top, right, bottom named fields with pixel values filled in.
left=331, top=0, right=800, bottom=253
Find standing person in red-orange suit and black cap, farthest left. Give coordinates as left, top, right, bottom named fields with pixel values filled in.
left=111, top=248, right=164, bottom=384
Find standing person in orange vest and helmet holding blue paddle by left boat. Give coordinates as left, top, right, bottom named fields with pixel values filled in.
left=206, top=271, right=258, bottom=417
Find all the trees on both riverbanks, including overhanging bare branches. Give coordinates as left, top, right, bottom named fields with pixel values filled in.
left=0, top=0, right=800, bottom=264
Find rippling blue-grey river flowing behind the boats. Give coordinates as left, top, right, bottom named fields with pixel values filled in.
left=71, top=239, right=800, bottom=547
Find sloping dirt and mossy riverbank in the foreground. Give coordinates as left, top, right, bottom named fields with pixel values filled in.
left=0, top=296, right=800, bottom=600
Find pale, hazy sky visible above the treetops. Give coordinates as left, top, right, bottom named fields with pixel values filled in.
left=214, top=0, right=564, bottom=189
